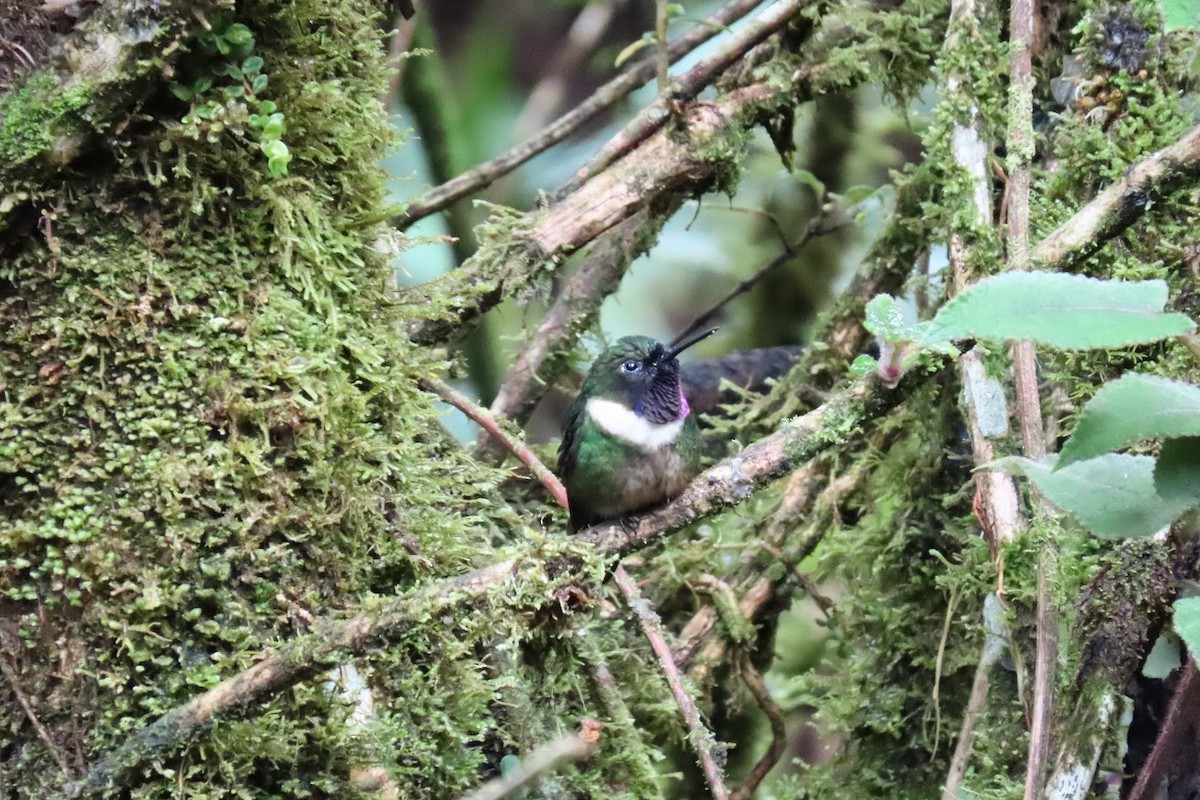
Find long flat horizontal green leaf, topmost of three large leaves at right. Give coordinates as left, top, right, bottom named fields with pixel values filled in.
left=920, top=272, right=1195, bottom=350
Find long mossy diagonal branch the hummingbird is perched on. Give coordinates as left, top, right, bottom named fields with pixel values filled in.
left=60, top=372, right=916, bottom=798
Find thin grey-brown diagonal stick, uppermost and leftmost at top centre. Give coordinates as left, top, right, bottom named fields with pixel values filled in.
left=392, top=0, right=762, bottom=229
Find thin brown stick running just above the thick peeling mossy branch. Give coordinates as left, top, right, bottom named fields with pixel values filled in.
left=551, top=0, right=814, bottom=201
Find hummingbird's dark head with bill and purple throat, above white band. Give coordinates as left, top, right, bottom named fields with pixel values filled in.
left=583, top=329, right=716, bottom=425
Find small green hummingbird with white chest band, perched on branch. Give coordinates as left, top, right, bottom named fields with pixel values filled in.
left=558, top=327, right=716, bottom=530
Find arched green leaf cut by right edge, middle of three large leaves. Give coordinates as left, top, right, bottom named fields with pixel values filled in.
left=1058, top=373, right=1200, bottom=468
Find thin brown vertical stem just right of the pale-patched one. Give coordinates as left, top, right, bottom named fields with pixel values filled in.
left=1007, top=0, right=1058, bottom=800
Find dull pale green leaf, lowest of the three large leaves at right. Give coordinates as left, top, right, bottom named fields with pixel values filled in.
left=991, top=453, right=1188, bottom=539
